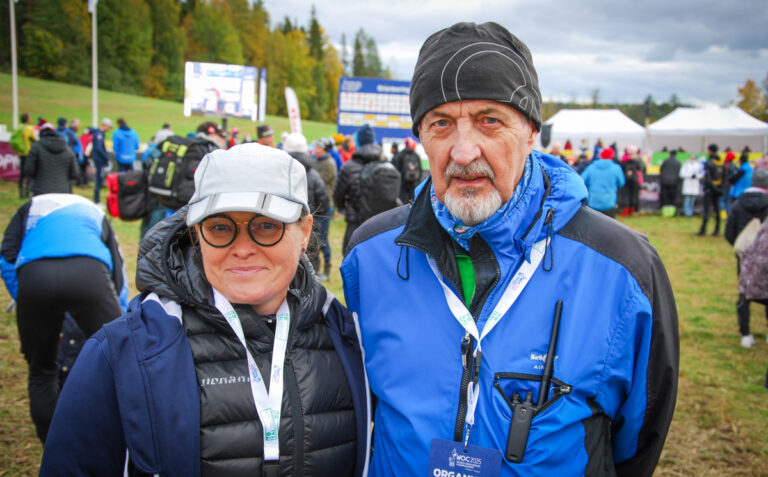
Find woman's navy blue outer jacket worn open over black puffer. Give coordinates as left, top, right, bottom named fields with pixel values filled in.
left=40, top=209, right=370, bottom=477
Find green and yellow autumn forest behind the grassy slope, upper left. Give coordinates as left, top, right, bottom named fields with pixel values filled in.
left=0, top=0, right=389, bottom=122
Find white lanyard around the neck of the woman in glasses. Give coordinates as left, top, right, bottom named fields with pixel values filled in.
left=213, top=288, right=291, bottom=460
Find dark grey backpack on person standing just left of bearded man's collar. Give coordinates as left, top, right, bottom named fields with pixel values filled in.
left=359, top=161, right=400, bottom=223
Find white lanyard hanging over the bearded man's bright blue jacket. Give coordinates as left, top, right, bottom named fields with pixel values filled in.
left=428, top=239, right=549, bottom=446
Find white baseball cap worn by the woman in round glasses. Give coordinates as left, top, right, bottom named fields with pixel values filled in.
left=187, top=142, right=310, bottom=226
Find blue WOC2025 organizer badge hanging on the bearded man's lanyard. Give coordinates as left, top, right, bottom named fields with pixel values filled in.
left=429, top=439, right=501, bottom=477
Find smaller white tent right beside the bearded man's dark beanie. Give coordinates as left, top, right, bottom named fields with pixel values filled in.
left=537, top=109, right=645, bottom=151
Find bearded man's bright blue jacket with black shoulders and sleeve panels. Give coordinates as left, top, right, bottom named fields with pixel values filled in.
left=341, top=151, right=679, bottom=476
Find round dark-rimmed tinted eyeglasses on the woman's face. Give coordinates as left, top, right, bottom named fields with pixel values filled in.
left=200, top=215, right=285, bottom=248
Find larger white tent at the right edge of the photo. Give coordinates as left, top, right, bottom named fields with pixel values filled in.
left=648, top=106, right=768, bottom=152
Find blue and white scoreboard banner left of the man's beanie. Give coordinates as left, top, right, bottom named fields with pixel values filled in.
left=337, top=76, right=413, bottom=143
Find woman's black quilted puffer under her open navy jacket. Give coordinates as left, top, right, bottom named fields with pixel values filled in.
left=183, top=290, right=356, bottom=477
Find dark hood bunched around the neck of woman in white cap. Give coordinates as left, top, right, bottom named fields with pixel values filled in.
left=136, top=206, right=326, bottom=328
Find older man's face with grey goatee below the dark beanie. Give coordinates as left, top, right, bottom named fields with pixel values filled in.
left=419, top=100, right=538, bottom=225
